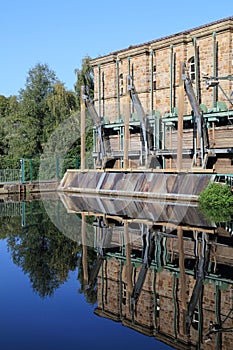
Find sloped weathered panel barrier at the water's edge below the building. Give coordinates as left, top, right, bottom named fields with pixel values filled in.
left=58, top=169, right=214, bottom=201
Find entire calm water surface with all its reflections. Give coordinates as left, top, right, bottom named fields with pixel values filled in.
left=0, top=193, right=233, bottom=350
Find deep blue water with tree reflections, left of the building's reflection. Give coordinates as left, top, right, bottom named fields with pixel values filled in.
left=0, top=197, right=171, bottom=350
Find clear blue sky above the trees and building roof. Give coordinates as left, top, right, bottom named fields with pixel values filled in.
left=0, top=0, right=233, bottom=97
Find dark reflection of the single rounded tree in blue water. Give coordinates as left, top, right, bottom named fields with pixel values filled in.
left=7, top=202, right=79, bottom=298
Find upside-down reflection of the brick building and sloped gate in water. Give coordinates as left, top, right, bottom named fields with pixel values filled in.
left=62, top=195, right=233, bottom=349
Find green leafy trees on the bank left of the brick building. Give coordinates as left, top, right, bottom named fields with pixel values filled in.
left=0, top=57, right=94, bottom=179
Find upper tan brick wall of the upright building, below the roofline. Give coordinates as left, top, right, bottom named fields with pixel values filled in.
left=92, top=17, right=233, bottom=121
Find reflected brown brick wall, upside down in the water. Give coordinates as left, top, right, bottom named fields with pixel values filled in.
left=95, top=231, right=233, bottom=350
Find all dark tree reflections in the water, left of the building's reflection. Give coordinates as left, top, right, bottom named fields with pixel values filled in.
left=0, top=200, right=97, bottom=304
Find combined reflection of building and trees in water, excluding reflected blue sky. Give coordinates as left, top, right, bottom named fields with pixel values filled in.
left=0, top=195, right=233, bottom=349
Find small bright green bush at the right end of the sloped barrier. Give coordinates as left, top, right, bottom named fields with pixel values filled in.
left=199, top=182, right=233, bottom=222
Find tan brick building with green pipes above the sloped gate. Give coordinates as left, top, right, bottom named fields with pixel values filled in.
left=88, top=17, right=233, bottom=173
